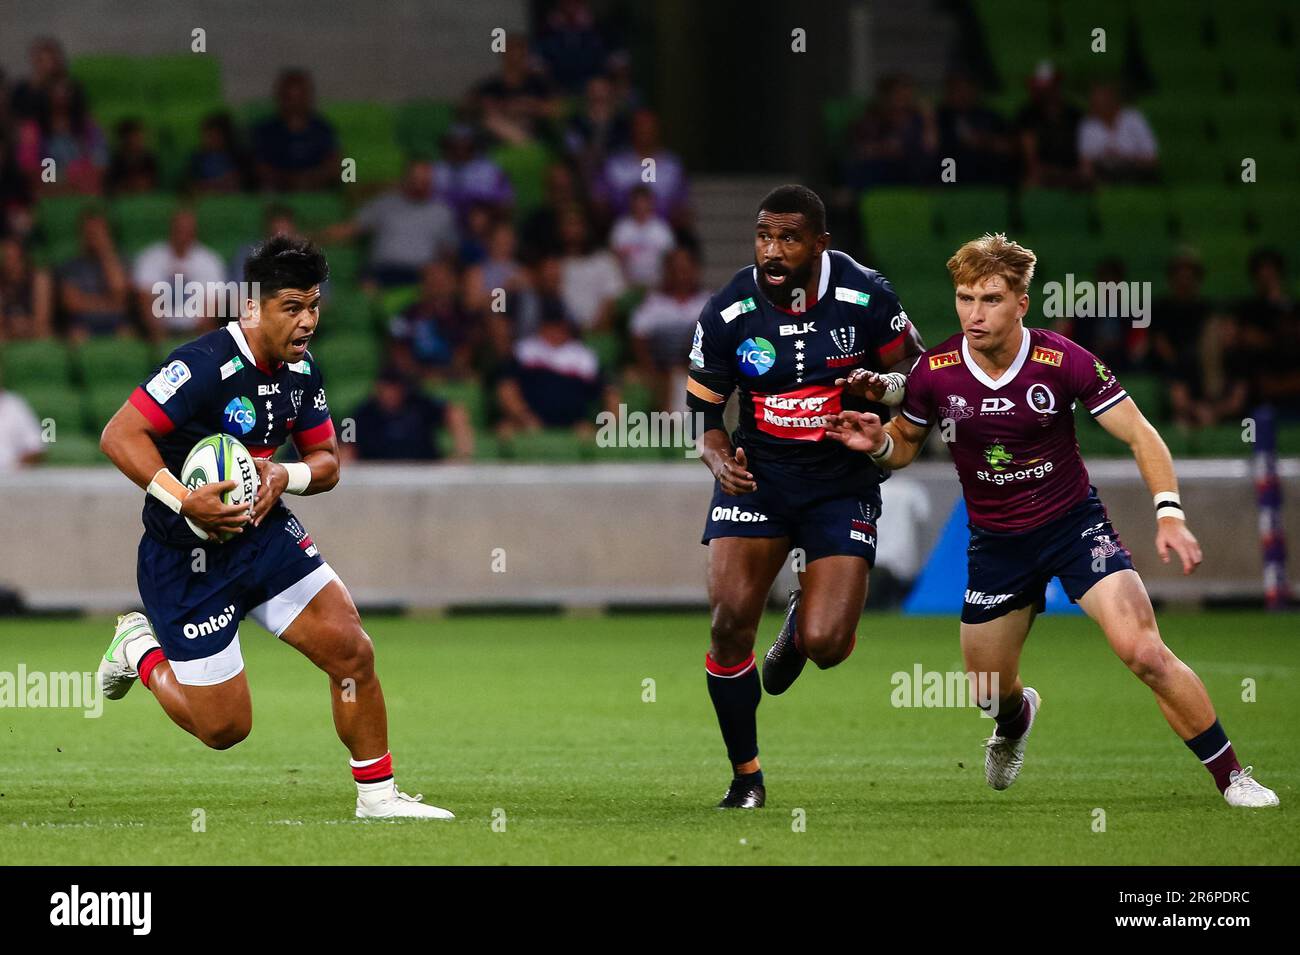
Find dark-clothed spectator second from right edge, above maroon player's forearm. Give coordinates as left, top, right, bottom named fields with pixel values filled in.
left=1151, top=249, right=1219, bottom=427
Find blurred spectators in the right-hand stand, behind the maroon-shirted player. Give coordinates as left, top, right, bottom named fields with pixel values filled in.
left=837, top=61, right=1300, bottom=429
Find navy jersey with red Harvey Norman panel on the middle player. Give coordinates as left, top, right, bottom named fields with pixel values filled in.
left=690, top=252, right=910, bottom=478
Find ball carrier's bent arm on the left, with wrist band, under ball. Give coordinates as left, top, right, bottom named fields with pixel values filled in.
left=99, top=401, right=248, bottom=534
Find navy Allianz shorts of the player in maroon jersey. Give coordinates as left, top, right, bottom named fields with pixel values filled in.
left=962, top=487, right=1132, bottom=624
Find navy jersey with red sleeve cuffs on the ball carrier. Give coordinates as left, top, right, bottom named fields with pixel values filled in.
left=130, top=321, right=334, bottom=547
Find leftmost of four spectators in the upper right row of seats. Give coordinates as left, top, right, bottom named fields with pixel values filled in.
left=848, top=73, right=939, bottom=188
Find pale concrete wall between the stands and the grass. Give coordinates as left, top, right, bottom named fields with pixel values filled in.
left=0, top=459, right=1300, bottom=611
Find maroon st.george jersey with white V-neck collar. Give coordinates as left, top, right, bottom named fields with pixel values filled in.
left=902, top=329, right=1127, bottom=531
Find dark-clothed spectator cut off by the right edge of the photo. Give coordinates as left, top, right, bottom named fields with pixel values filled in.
left=1235, top=248, right=1300, bottom=421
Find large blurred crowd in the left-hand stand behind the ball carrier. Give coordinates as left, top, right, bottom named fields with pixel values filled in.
left=0, top=0, right=707, bottom=467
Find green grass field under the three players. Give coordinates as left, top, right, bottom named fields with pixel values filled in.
left=0, top=613, right=1300, bottom=865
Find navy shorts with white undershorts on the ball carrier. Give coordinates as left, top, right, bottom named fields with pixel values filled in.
left=135, top=507, right=337, bottom=686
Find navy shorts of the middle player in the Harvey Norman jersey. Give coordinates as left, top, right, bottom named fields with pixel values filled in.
left=701, top=461, right=880, bottom=567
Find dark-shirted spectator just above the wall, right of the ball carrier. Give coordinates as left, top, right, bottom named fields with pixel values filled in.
left=339, top=366, right=475, bottom=461
